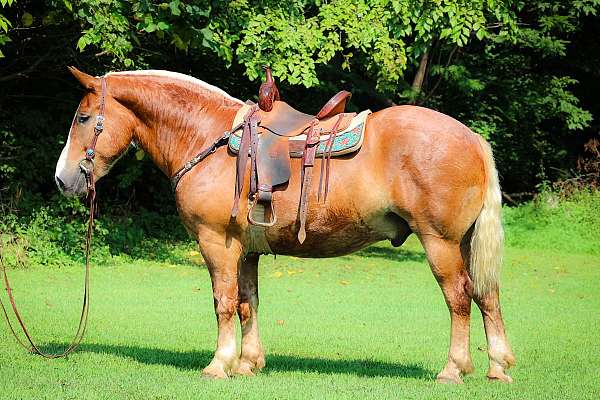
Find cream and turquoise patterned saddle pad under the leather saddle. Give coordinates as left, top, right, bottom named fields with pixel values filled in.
left=229, top=111, right=371, bottom=158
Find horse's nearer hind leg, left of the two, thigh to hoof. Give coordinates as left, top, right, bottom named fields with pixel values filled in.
left=420, top=235, right=473, bottom=383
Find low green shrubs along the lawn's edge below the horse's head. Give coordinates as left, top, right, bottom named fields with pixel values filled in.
left=0, top=197, right=193, bottom=267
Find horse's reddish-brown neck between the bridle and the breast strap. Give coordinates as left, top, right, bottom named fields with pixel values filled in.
left=108, top=76, right=241, bottom=176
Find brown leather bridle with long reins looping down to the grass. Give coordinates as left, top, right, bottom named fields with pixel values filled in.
left=0, top=76, right=106, bottom=358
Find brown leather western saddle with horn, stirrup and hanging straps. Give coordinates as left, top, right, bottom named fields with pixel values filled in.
left=231, top=67, right=356, bottom=243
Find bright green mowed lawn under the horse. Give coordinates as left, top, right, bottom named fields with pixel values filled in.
left=0, top=238, right=600, bottom=399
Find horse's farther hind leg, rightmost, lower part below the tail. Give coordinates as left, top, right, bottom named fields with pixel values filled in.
left=474, top=288, right=515, bottom=383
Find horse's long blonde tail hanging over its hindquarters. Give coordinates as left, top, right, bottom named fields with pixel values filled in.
left=470, top=136, right=504, bottom=296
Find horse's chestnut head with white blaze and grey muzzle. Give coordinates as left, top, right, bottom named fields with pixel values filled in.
left=54, top=67, right=136, bottom=196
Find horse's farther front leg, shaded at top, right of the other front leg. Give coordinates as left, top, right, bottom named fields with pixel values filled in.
left=234, top=254, right=265, bottom=376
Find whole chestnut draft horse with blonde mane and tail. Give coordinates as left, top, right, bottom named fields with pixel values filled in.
left=55, top=68, right=515, bottom=383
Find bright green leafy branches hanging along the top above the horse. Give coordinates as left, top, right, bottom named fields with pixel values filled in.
left=0, top=0, right=516, bottom=92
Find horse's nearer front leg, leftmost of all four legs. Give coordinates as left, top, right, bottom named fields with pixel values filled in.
left=199, top=231, right=242, bottom=378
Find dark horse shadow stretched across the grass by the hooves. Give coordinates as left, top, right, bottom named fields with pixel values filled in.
left=47, top=343, right=435, bottom=380
